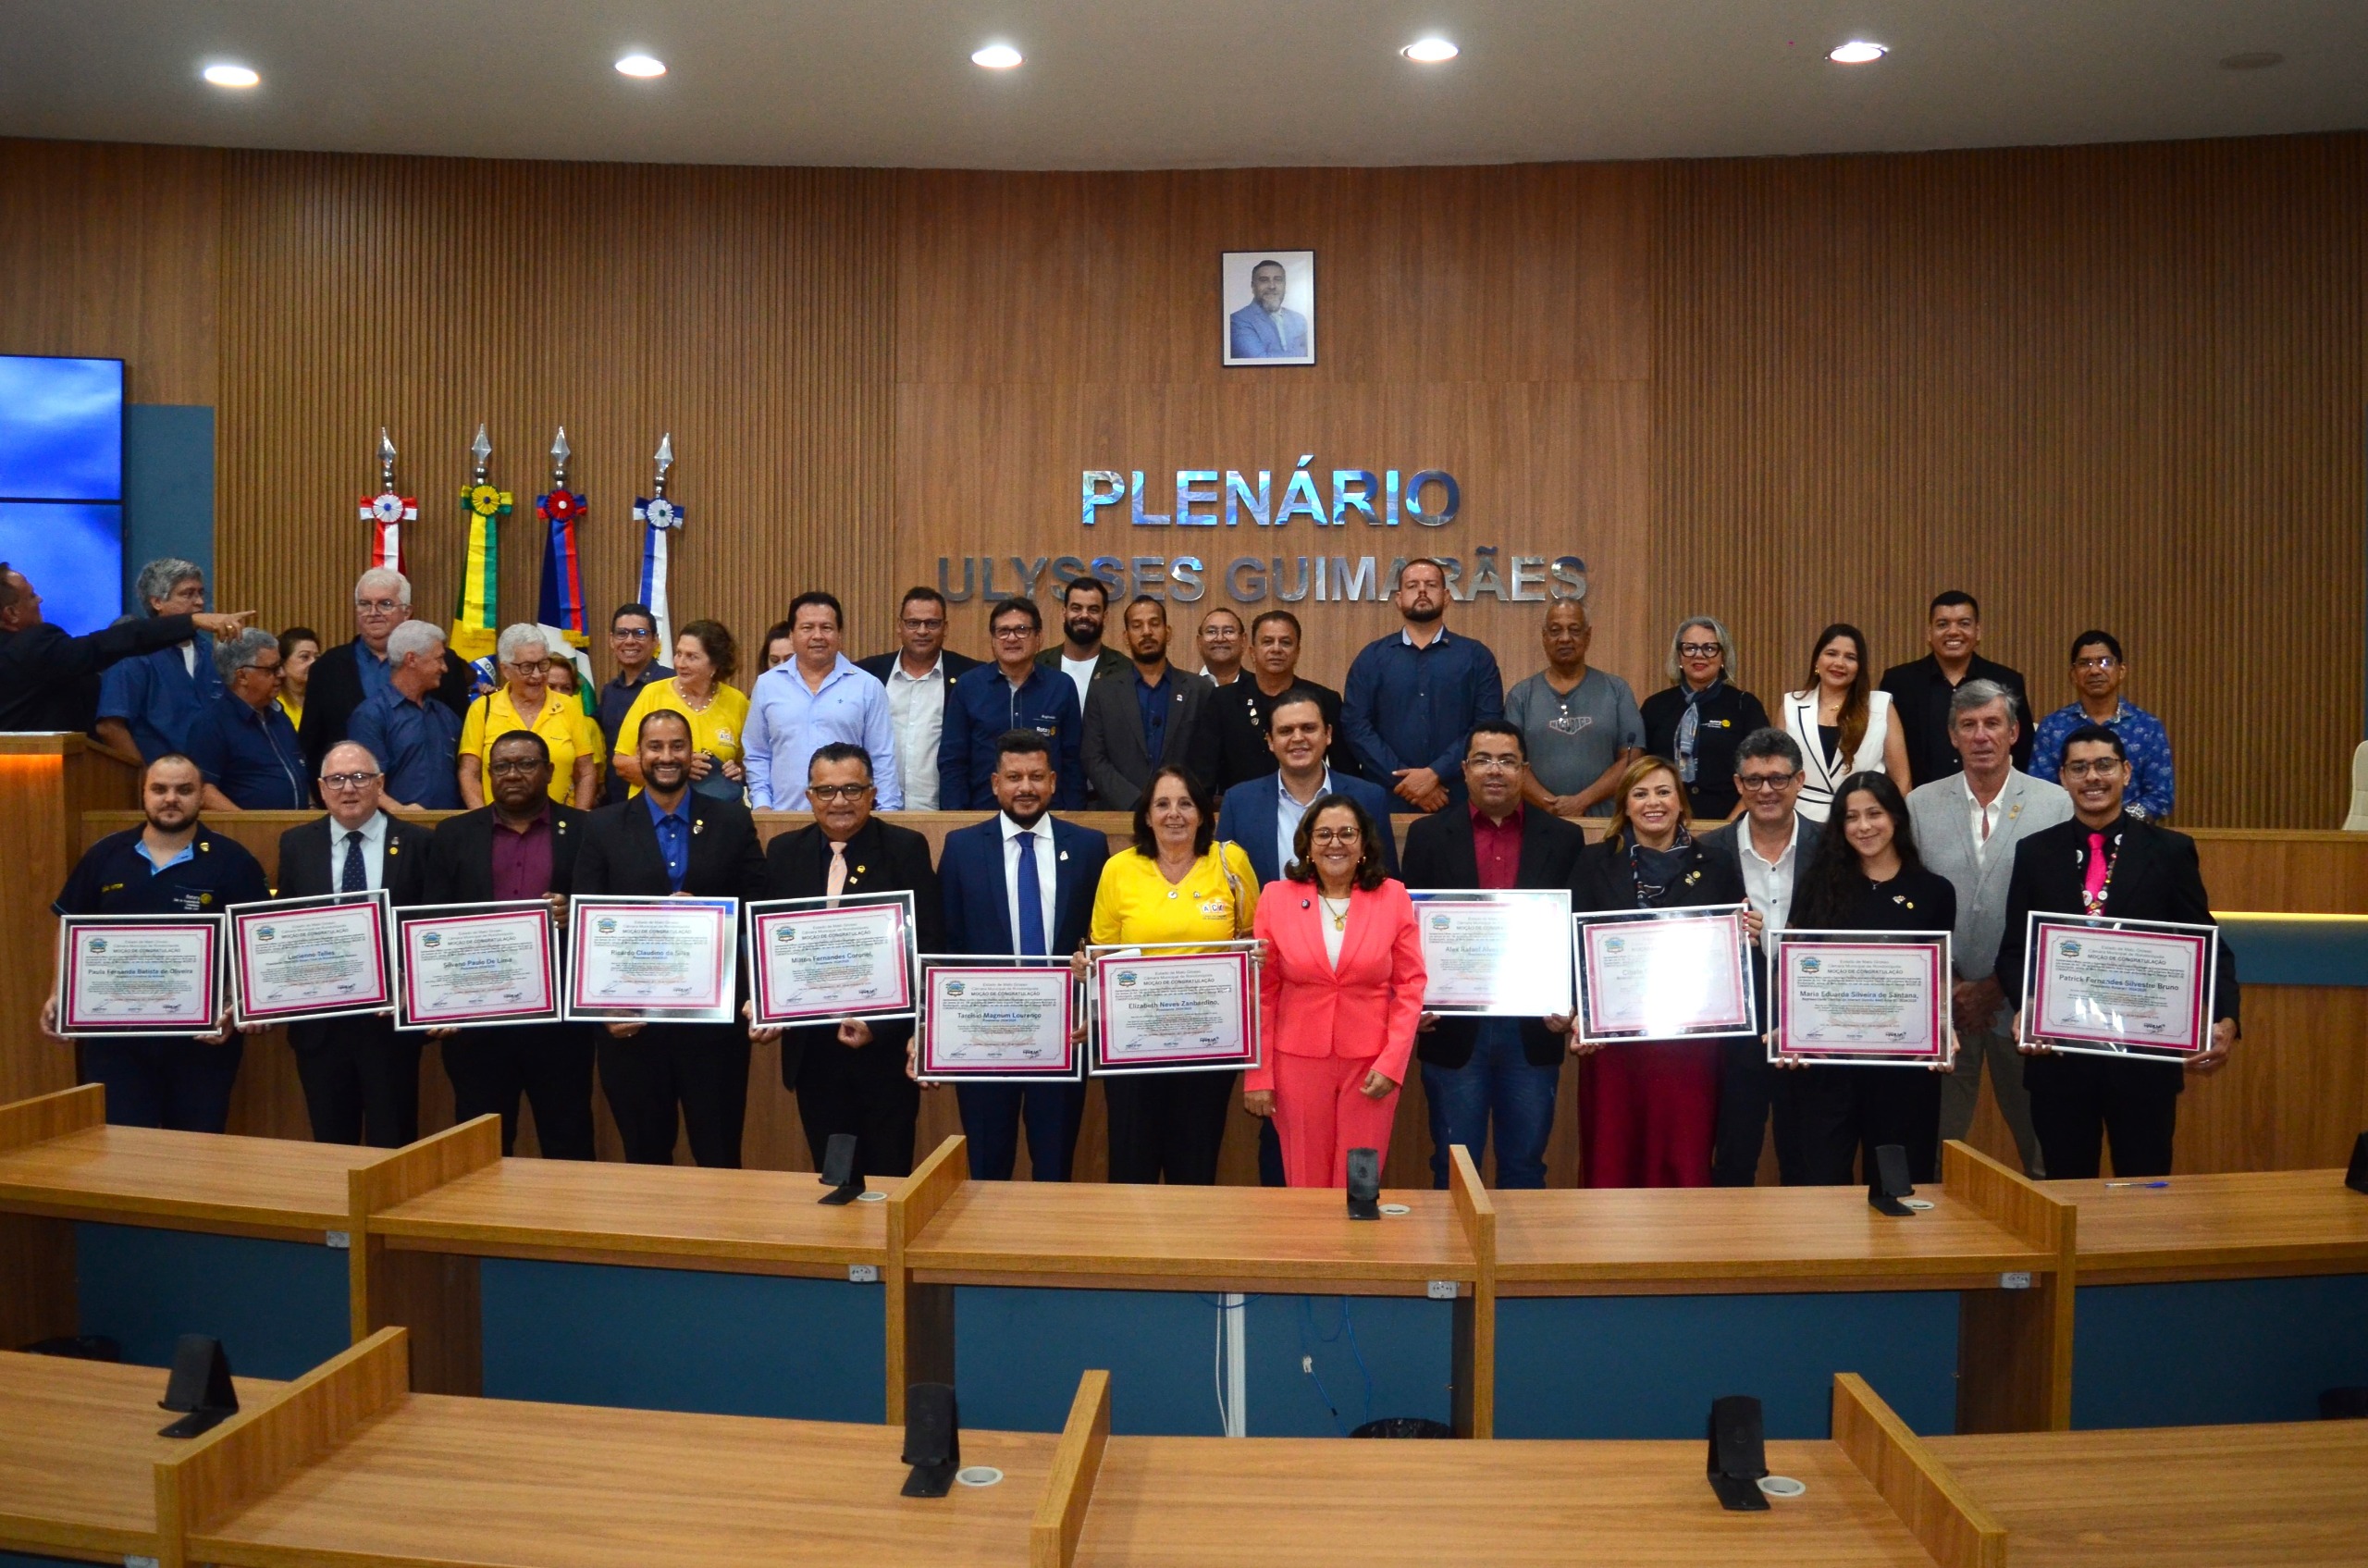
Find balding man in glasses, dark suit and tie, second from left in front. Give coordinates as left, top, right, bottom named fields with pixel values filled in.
left=279, top=741, right=431, bottom=1149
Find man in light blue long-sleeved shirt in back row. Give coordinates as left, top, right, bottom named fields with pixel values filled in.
left=741, top=592, right=905, bottom=810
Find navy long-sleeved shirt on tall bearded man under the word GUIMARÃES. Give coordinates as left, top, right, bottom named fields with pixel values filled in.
left=1340, top=628, right=1504, bottom=810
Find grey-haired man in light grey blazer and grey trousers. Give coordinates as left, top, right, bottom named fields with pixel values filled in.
left=1908, top=680, right=2072, bottom=1179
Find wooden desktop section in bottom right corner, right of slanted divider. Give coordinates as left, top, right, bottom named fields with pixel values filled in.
left=1930, top=1421, right=2368, bottom=1568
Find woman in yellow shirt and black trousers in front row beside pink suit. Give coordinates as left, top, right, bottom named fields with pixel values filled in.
left=1092, top=768, right=1257, bottom=1187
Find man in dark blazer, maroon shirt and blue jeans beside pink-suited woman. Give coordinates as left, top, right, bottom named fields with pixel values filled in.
left=1401, top=724, right=1586, bottom=1187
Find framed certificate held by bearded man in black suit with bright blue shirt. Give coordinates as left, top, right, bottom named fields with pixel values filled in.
left=561, top=893, right=739, bottom=1023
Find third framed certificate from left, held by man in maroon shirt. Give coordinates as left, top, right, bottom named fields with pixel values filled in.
left=396, top=897, right=559, bottom=1028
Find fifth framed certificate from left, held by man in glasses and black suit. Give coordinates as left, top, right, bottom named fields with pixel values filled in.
left=748, top=893, right=919, bottom=1023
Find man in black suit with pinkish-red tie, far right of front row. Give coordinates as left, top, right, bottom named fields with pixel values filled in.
left=1999, top=724, right=2238, bottom=1179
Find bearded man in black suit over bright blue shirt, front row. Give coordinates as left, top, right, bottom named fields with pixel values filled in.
left=574, top=709, right=765, bottom=1167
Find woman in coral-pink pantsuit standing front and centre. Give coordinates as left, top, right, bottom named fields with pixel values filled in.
left=1240, top=796, right=1425, bottom=1187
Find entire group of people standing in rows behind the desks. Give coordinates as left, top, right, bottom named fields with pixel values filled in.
left=0, top=547, right=2236, bottom=1187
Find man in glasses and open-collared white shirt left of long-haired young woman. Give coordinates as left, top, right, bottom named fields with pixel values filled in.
left=1703, top=727, right=1819, bottom=1187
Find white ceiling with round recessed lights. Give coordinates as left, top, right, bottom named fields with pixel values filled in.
left=0, top=0, right=2368, bottom=168
